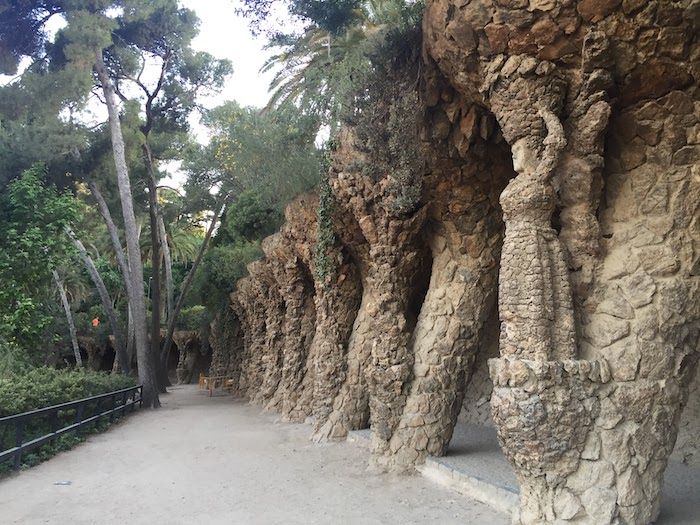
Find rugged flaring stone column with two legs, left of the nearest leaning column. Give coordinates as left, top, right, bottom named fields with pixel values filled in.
left=314, top=126, right=426, bottom=455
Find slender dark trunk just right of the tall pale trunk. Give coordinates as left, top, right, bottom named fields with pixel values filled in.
left=141, top=141, right=168, bottom=393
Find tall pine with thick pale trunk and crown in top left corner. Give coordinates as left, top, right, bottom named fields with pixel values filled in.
left=0, top=0, right=160, bottom=407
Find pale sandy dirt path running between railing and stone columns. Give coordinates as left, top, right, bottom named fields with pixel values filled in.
left=0, top=387, right=509, bottom=525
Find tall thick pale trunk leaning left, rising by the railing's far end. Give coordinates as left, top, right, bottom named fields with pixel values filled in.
left=95, top=49, right=160, bottom=408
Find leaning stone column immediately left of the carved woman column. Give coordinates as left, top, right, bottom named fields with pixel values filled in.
left=380, top=67, right=512, bottom=470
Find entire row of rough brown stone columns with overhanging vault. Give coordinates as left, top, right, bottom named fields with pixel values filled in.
left=206, top=0, right=700, bottom=524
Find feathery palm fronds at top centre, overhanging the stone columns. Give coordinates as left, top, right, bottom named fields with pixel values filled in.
left=263, top=0, right=423, bottom=128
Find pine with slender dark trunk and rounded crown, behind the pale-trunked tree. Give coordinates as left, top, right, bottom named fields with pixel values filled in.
left=100, top=0, right=231, bottom=391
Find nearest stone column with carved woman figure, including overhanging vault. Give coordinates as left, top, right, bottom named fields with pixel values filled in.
left=426, top=0, right=700, bottom=523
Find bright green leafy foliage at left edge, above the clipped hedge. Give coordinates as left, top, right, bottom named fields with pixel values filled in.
left=0, top=166, right=78, bottom=350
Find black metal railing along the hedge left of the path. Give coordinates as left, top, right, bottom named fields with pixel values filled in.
left=0, top=385, right=143, bottom=469
